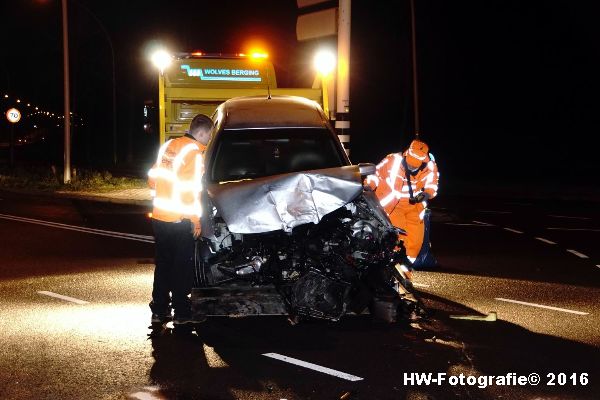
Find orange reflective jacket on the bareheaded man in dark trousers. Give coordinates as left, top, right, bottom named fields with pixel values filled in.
left=148, top=136, right=206, bottom=226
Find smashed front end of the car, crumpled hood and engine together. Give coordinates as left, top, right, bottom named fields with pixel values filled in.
left=192, top=166, right=420, bottom=322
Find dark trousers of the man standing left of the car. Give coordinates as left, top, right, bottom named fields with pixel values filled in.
left=150, top=219, right=194, bottom=316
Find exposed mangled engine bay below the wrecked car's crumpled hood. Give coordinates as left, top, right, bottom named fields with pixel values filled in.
left=197, top=191, right=414, bottom=320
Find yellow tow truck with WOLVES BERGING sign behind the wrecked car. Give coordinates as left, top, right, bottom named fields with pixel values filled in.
left=158, top=53, right=327, bottom=144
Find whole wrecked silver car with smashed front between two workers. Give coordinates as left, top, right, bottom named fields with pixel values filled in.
left=192, top=96, right=417, bottom=322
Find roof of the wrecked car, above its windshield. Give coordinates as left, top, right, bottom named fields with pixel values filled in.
left=222, top=96, right=327, bottom=129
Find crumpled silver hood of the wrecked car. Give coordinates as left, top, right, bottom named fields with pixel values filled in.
left=208, top=165, right=363, bottom=233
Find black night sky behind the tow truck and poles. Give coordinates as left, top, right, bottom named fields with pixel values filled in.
left=0, top=0, right=600, bottom=184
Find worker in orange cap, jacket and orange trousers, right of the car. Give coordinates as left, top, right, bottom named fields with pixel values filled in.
left=367, top=140, right=439, bottom=263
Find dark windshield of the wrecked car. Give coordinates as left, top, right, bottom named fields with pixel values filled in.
left=210, top=128, right=345, bottom=182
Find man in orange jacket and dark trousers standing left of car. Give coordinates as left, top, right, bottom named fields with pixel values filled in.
left=148, top=114, right=213, bottom=325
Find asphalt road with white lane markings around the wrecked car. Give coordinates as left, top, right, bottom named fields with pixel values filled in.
left=0, top=192, right=600, bottom=400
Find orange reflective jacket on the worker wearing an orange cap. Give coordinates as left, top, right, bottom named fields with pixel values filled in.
left=367, top=153, right=439, bottom=214
